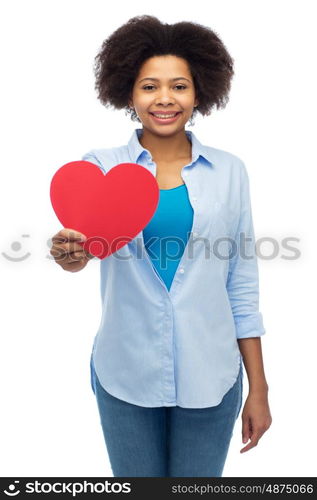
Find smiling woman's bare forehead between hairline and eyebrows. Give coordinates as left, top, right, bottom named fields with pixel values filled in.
left=138, top=55, right=191, bottom=78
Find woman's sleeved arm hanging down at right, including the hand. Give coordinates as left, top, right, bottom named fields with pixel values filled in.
left=227, top=163, right=272, bottom=453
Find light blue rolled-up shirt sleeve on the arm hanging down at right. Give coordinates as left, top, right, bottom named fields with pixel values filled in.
left=227, top=162, right=266, bottom=339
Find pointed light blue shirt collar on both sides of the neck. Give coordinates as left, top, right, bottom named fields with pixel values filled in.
left=128, top=128, right=214, bottom=166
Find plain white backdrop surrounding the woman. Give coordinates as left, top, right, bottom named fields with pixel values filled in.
left=0, top=0, right=317, bottom=477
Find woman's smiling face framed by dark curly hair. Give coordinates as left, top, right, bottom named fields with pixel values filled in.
left=129, top=55, right=198, bottom=136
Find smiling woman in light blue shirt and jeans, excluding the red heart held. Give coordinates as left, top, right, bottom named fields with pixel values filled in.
left=51, top=16, right=272, bottom=477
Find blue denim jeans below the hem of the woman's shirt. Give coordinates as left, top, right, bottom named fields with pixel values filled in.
left=90, top=352, right=243, bottom=477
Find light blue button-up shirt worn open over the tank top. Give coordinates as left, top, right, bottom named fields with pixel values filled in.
left=82, top=129, right=265, bottom=408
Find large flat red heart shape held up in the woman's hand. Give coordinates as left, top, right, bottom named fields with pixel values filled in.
left=50, top=161, right=159, bottom=259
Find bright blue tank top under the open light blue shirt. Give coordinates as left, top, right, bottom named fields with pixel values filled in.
left=143, top=184, right=193, bottom=290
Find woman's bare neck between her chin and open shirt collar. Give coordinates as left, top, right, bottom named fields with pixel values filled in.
left=139, top=128, right=192, bottom=162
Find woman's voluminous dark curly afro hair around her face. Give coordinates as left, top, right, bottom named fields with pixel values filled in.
left=94, top=15, right=234, bottom=122
